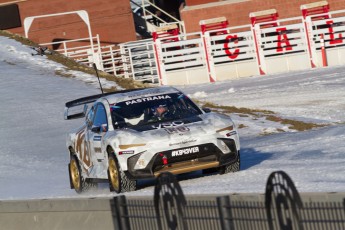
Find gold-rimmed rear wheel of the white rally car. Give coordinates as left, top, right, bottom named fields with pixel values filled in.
left=68, top=155, right=97, bottom=194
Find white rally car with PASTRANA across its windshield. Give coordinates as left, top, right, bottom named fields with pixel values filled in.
left=65, top=87, right=240, bottom=193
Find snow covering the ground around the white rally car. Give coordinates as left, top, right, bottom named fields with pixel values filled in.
left=0, top=37, right=345, bottom=200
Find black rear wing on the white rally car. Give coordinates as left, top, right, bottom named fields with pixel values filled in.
left=64, top=88, right=146, bottom=120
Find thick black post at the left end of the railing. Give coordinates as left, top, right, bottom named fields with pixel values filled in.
left=114, top=195, right=131, bottom=230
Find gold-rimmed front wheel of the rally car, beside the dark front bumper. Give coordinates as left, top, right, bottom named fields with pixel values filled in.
left=108, top=153, right=137, bottom=193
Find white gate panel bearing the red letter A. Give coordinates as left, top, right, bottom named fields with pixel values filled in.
left=254, top=17, right=310, bottom=74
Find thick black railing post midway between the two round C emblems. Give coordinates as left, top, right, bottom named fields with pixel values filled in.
left=217, top=196, right=235, bottom=230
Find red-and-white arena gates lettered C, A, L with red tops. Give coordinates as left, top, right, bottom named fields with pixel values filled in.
left=150, top=2, right=345, bottom=85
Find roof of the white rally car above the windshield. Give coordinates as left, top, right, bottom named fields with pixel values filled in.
left=102, top=86, right=181, bottom=104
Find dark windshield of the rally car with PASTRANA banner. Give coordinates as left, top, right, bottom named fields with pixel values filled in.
left=110, top=93, right=202, bottom=128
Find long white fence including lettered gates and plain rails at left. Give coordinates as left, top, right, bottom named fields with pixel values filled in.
left=40, top=10, right=345, bottom=85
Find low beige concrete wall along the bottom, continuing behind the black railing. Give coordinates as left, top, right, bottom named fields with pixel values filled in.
left=0, top=193, right=345, bottom=230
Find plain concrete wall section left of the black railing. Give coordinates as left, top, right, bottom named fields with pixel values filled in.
left=0, top=198, right=117, bottom=230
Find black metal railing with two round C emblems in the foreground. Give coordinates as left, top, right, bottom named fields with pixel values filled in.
left=115, top=171, right=345, bottom=230
